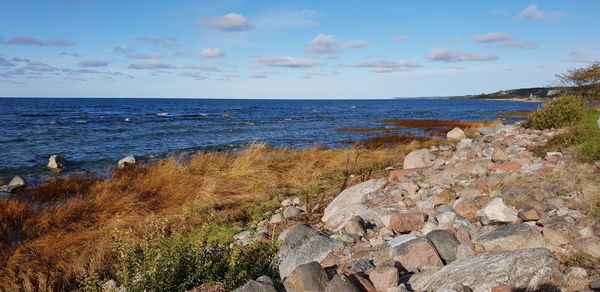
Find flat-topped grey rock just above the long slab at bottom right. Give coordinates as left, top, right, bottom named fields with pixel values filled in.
left=473, top=223, right=544, bottom=252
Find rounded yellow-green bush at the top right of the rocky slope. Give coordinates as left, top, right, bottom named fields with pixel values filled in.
left=526, top=95, right=585, bottom=130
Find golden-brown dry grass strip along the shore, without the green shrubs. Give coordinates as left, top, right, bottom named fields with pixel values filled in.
left=0, top=142, right=435, bottom=291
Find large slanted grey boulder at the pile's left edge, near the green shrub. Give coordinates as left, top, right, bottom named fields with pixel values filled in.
left=279, top=234, right=344, bottom=279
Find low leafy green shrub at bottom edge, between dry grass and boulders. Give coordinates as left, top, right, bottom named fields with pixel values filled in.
left=117, top=230, right=277, bottom=291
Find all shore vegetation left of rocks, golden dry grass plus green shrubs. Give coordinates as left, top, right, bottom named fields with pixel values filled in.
left=0, top=141, right=439, bottom=291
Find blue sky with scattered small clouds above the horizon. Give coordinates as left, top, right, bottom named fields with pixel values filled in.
left=0, top=0, right=600, bottom=99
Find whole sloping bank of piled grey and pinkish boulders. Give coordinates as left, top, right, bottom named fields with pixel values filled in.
left=234, top=124, right=600, bottom=292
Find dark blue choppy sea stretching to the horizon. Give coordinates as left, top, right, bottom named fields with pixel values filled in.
left=0, top=98, right=538, bottom=179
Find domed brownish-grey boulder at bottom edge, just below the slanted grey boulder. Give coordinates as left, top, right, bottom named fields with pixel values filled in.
left=283, top=262, right=329, bottom=292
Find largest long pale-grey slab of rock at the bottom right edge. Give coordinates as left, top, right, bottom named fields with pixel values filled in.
left=410, top=248, right=563, bottom=292
